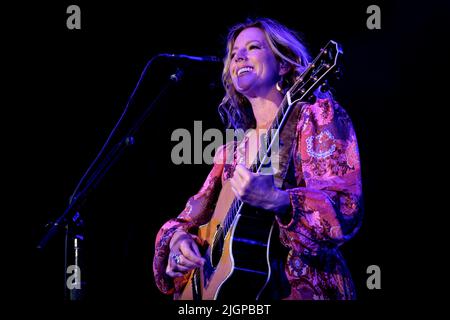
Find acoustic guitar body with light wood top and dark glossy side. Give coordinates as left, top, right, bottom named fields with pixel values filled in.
left=179, top=181, right=275, bottom=300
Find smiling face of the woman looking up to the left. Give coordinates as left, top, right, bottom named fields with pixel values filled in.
left=230, top=27, right=281, bottom=97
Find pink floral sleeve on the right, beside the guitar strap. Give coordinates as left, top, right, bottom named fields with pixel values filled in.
left=277, top=99, right=362, bottom=246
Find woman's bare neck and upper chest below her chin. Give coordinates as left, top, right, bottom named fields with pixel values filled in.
left=248, top=88, right=283, bottom=129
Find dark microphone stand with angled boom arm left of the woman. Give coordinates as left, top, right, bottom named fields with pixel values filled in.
left=37, top=61, right=183, bottom=300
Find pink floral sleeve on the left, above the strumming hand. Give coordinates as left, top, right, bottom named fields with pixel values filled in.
left=153, top=147, right=229, bottom=294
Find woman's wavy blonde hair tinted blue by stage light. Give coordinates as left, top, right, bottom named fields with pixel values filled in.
left=218, top=18, right=310, bottom=130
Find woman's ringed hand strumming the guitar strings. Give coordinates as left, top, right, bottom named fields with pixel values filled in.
left=166, top=231, right=205, bottom=278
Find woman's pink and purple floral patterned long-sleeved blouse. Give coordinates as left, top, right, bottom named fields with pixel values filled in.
left=153, top=99, right=362, bottom=300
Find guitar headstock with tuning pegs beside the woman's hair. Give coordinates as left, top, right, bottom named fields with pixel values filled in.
left=286, top=40, right=343, bottom=105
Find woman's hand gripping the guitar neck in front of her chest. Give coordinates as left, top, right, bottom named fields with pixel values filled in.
left=230, top=164, right=290, bottom=213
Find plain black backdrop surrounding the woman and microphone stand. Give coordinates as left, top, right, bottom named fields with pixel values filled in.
left=5, top=1, right=449, bottom=312
